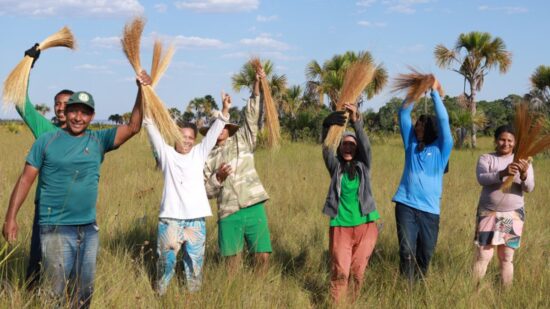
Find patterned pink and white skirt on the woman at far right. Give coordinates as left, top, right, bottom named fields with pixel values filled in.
left=474, top=207, right=525, bottom=249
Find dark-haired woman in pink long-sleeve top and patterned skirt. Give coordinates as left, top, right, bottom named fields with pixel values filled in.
left=474, top=126, right=535, bottom=287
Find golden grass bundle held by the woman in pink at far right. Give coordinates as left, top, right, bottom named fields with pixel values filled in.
left=500, top=102, right=550, bottom=191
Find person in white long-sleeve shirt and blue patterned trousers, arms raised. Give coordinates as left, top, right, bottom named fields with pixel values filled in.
left=144, top=94, right=231, bottom=295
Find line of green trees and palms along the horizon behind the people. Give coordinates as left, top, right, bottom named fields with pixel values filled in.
left=101, top=32, right=550, bottom=148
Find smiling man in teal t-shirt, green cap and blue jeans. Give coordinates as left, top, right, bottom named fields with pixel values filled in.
left=3, top=70, right=150, bottom=307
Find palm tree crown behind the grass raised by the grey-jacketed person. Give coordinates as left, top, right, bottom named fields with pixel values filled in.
left=306, top=51, right=388, bottom=110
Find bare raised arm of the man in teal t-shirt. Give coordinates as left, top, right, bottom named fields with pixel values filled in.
left=114, top=71, right=151, bottom=147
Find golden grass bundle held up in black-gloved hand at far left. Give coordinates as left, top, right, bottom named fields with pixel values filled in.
left=2, top=27, right=76, bottom=109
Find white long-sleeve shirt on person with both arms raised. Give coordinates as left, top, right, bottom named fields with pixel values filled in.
left=143, top=112, right=228, bottom=220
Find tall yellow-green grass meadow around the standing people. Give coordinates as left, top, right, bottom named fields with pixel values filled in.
left=0, top=126, right=550, bottom=308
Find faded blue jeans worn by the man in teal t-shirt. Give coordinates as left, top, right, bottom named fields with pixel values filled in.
left=40, top=223, right=99, bottom=308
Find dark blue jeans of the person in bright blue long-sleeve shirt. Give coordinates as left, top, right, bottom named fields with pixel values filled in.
left=395, top=203, right=439, bottom=282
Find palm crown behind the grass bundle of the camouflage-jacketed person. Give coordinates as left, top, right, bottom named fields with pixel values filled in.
left=231, top=60, right=287, bottom=98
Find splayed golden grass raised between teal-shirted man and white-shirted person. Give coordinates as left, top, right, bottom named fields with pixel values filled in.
left=121, top=17, right=182, bottom=145
